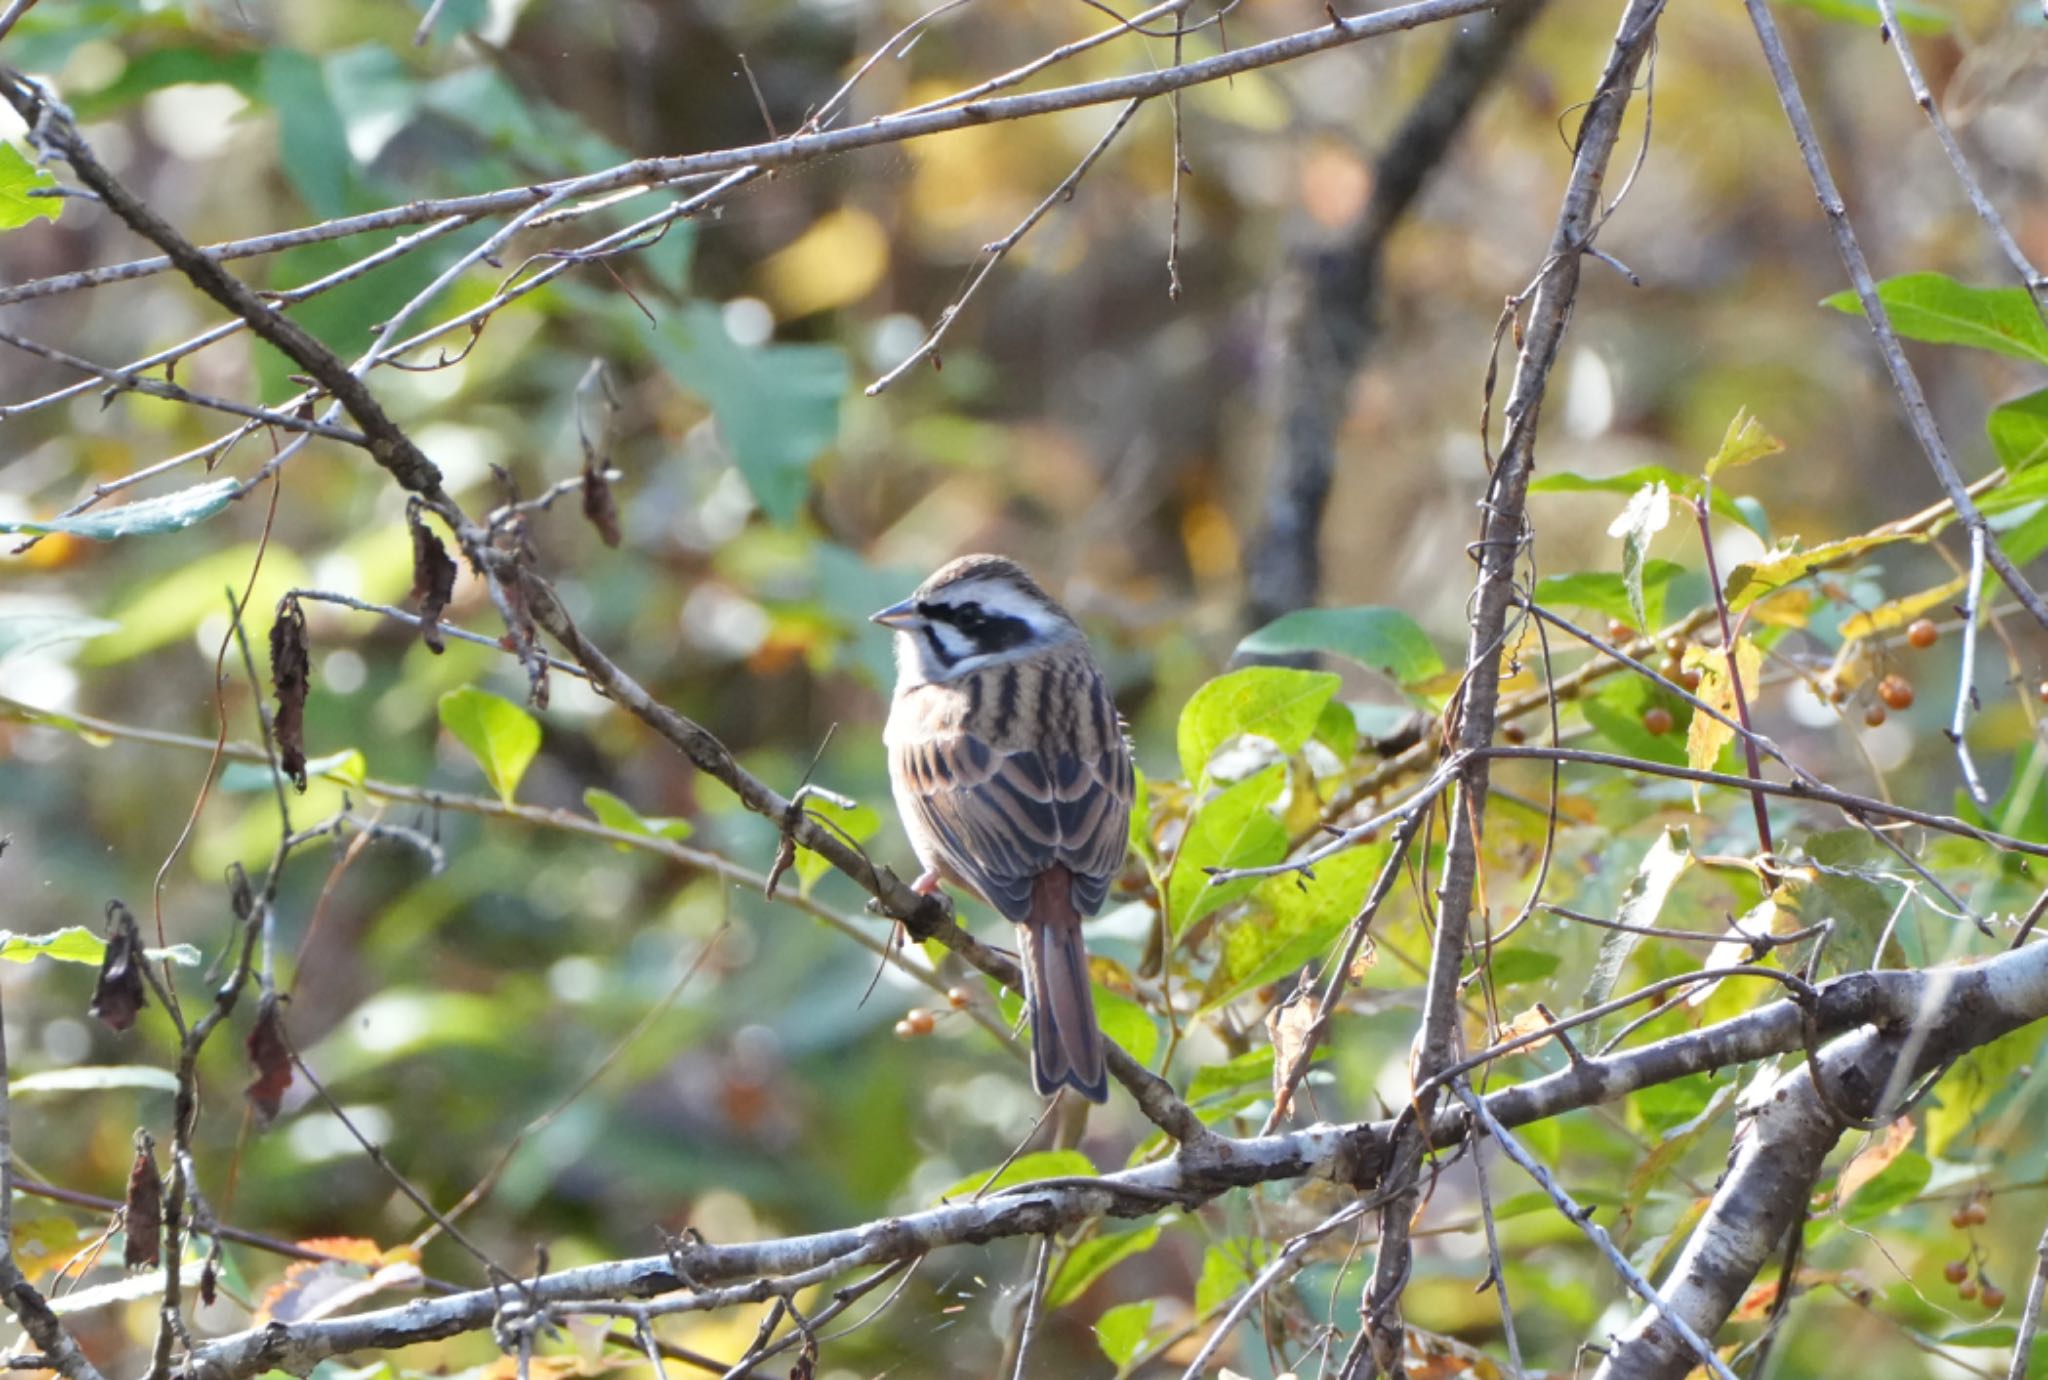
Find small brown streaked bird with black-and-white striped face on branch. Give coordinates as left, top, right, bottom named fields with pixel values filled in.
left=874, top=555, right=1135, bottom=1102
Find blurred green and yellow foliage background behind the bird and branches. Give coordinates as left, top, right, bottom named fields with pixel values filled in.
left=0, top=0, right=2048, bottom=1376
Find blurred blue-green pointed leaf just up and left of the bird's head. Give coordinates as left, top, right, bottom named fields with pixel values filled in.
left=653, top=303, right=848, bottom=524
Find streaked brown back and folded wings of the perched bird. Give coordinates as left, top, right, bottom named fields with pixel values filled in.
left=897, top=659, right=1133, bottom=921
